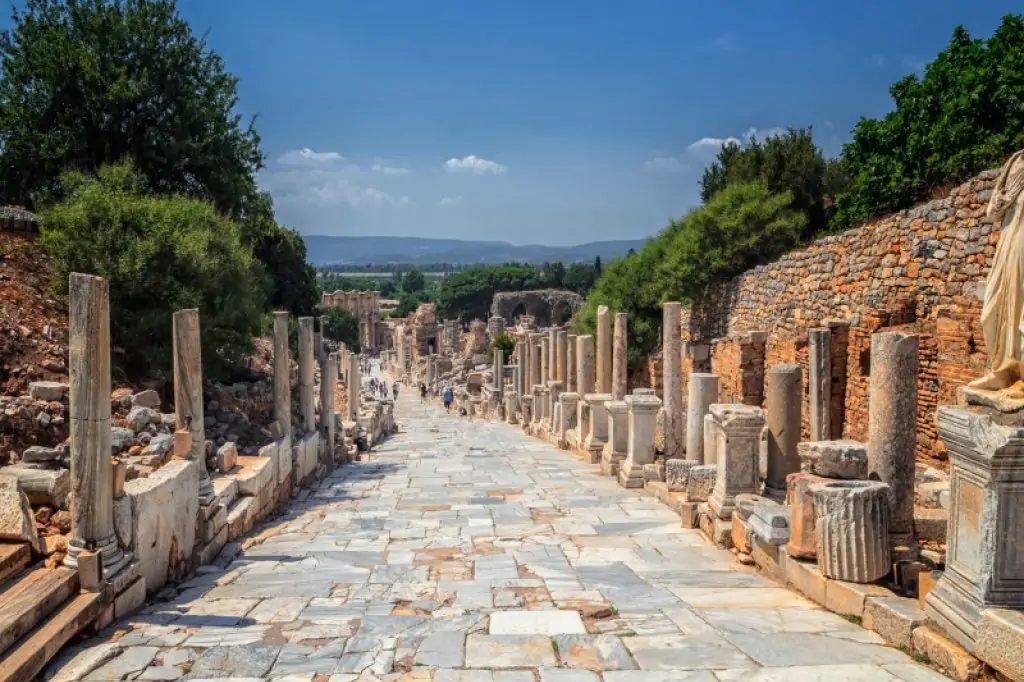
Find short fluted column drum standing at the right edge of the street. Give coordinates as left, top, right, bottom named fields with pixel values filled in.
left=810, top=480, right=892, bottom=583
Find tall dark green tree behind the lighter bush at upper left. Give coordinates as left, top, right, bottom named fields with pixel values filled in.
left=0, top=0, right=263, bottom=217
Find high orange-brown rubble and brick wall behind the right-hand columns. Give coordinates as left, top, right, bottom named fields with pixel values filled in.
left=682, top=171, right=999, bottom=459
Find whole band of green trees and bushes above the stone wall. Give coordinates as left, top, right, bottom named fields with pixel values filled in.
left=574, top=14, right=1024, bottom=368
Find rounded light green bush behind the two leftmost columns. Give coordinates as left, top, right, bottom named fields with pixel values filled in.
left=41, top=163, right=263, bottom=376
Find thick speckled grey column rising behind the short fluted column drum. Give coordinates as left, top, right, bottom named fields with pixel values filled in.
left=867, top=332, right=918, bottom=559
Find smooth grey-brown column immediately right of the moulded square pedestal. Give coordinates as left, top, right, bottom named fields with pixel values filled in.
left=765, top=365, right=804, bottom=502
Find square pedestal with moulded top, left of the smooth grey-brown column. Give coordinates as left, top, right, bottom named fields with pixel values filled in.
left=708, top=404, right=765, bottom=519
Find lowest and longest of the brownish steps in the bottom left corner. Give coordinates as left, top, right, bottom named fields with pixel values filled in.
left=0, top=592, right=109, bottom=682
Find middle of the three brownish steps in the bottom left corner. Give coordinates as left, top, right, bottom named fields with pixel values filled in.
left=0, top=566, right=78, bottom=653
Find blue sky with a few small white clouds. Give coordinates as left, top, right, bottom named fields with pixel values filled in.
left=9, top=0, right=1021, bottom=245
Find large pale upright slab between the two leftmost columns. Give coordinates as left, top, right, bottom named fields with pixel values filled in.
left=125, top=460, right=199, bottom=594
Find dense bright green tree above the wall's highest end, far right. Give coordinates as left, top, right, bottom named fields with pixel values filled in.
left=836, top=14, right=1024, bottom=226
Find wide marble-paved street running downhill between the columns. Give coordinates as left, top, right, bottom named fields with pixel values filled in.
left=50, top=366, right=945, bottom=682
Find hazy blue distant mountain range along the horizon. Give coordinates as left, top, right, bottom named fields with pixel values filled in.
left=303, top=235, right=646, bottom=265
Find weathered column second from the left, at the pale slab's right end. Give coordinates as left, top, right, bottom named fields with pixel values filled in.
left=171, top=308, right=214, bottom=505
